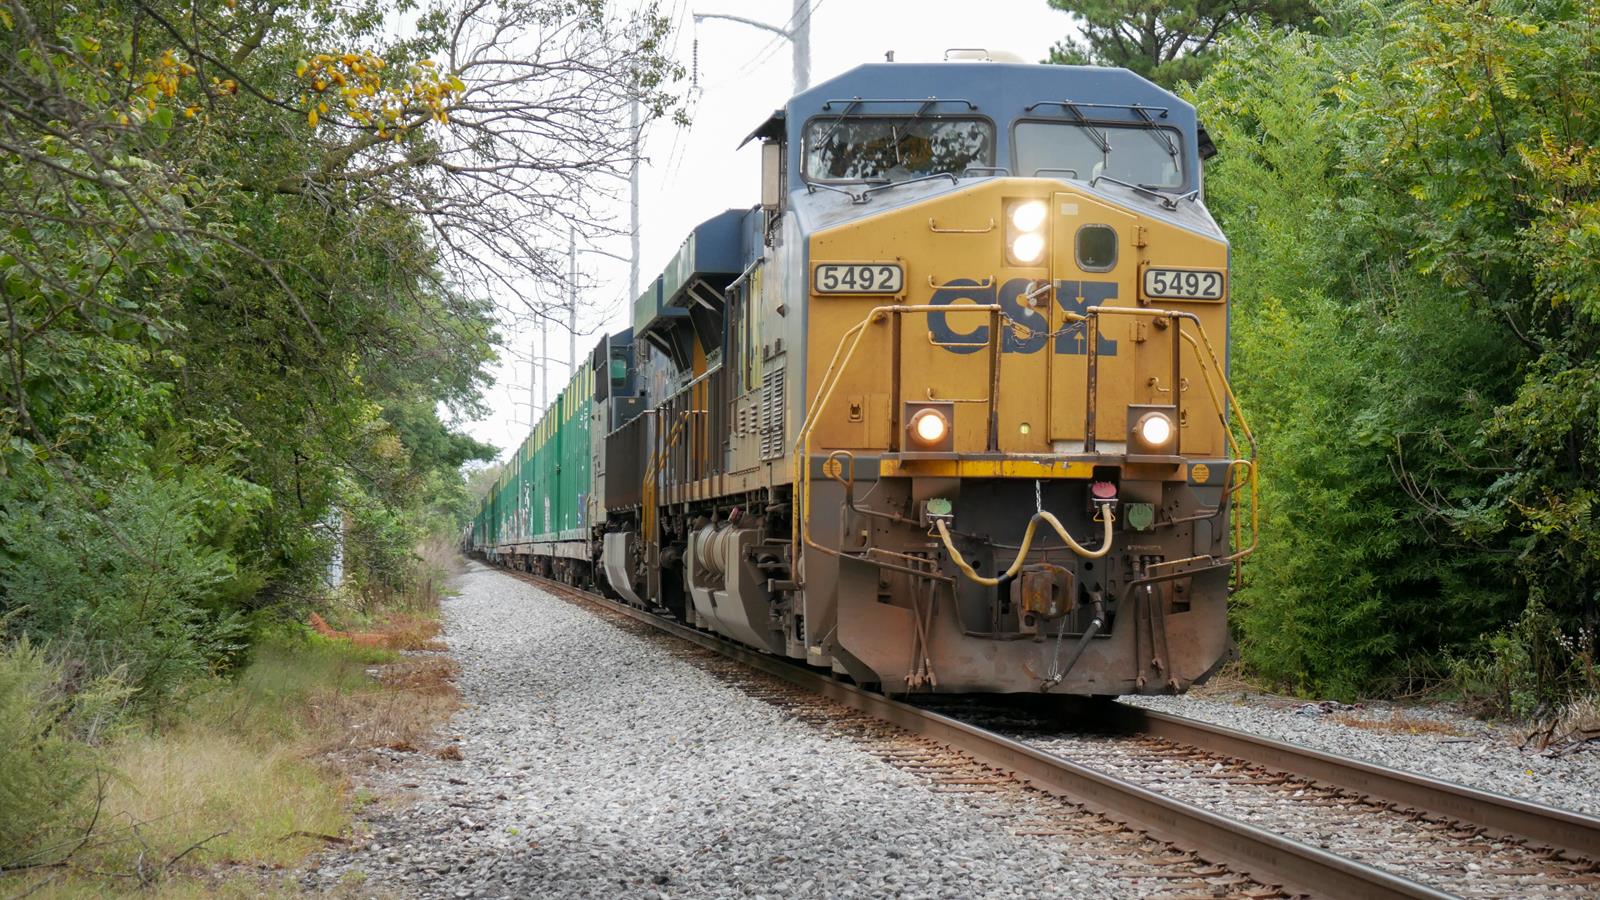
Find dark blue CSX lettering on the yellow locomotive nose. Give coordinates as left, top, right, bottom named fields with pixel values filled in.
left=928, top=279, right=1117, bottom=356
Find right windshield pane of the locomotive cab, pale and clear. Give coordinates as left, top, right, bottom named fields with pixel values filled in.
left=1016, top=122, right=1184, bottom=189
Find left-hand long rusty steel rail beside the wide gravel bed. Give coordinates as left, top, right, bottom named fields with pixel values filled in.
left=518, top=573, right=1451, bottom=898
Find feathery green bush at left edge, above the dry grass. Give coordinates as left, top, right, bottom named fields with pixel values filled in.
left=0, top=471, right=262, bottom=713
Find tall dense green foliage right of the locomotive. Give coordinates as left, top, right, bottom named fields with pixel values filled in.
left=1192, top=0, right=1600, bottom=701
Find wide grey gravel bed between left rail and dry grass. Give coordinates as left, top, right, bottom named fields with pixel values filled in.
left=301, top=564, right=1149, bottom=898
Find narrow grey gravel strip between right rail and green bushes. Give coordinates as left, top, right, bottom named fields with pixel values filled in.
left=1123, top=687, right=1600, bottom=815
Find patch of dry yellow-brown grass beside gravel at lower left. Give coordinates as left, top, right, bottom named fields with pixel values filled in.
left=0, top=615, right=458, bottom=898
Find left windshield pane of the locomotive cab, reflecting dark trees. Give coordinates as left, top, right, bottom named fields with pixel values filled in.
left=805, top=117, right=995, bottom=181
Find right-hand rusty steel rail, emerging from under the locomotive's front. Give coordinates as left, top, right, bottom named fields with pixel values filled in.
left=1107, top=703, right=1600, bottom=860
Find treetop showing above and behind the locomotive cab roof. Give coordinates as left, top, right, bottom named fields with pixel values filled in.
left=1050, top=0, right=1317, bottom=88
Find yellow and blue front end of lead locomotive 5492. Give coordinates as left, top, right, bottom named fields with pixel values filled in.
left=774, top=64, right=1253, bottom=693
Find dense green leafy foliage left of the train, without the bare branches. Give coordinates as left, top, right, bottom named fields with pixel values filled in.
left=0, top=0, right=537, bottom=713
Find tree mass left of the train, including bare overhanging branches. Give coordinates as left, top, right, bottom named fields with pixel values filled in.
left=0, top=0, right=678, bottom=698
